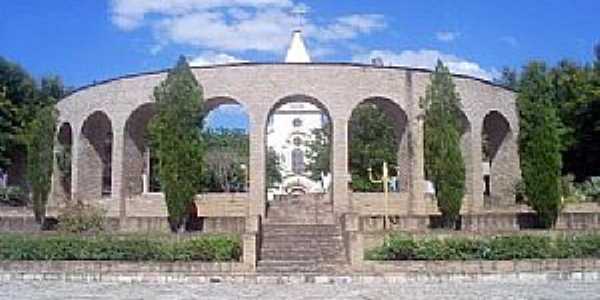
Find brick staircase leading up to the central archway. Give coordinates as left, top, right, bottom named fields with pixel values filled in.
left=257, top=195, right=346, bottom=274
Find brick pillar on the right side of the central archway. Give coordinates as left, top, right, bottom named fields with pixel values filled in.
left=331, top=116, right=350, bottom=216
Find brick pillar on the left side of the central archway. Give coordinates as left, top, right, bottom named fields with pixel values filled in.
left=248, top=109, right=267, bottom=217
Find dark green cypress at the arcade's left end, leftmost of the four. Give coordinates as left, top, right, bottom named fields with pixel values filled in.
left=25, top=106, right=58, bottom=224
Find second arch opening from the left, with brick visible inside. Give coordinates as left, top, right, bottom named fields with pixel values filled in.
left=77, top=111, right=114, bottom=201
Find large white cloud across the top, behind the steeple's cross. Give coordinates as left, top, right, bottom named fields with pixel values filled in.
left=111, top=0, right=386, bottom=53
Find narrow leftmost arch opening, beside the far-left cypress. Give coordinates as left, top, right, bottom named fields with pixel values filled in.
left=55, top=122, right=73, bottom=200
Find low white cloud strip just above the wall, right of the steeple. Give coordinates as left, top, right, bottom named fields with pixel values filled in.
left=353, top=49, right=495, bottom=80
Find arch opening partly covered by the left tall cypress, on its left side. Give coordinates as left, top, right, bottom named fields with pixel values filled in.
left=122, top=103, right=156, bottom=198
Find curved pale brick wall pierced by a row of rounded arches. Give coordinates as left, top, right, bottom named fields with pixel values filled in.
left=57, top=64, right=520, bottom=227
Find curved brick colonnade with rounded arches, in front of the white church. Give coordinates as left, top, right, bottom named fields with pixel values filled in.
left=53, top=64, right=520, bottom=223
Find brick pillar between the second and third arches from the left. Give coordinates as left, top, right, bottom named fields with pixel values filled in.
left=111, top=124, right=127, bottom=218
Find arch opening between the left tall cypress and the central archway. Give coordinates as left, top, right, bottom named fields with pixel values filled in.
left=203, top=96, right=251, bottom=193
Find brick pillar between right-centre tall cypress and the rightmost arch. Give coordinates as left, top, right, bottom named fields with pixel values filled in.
left=472, top=122, right=483, bottom=213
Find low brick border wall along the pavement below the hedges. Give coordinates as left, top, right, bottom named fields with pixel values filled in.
left=0, top=259, right=600, bottom=284
